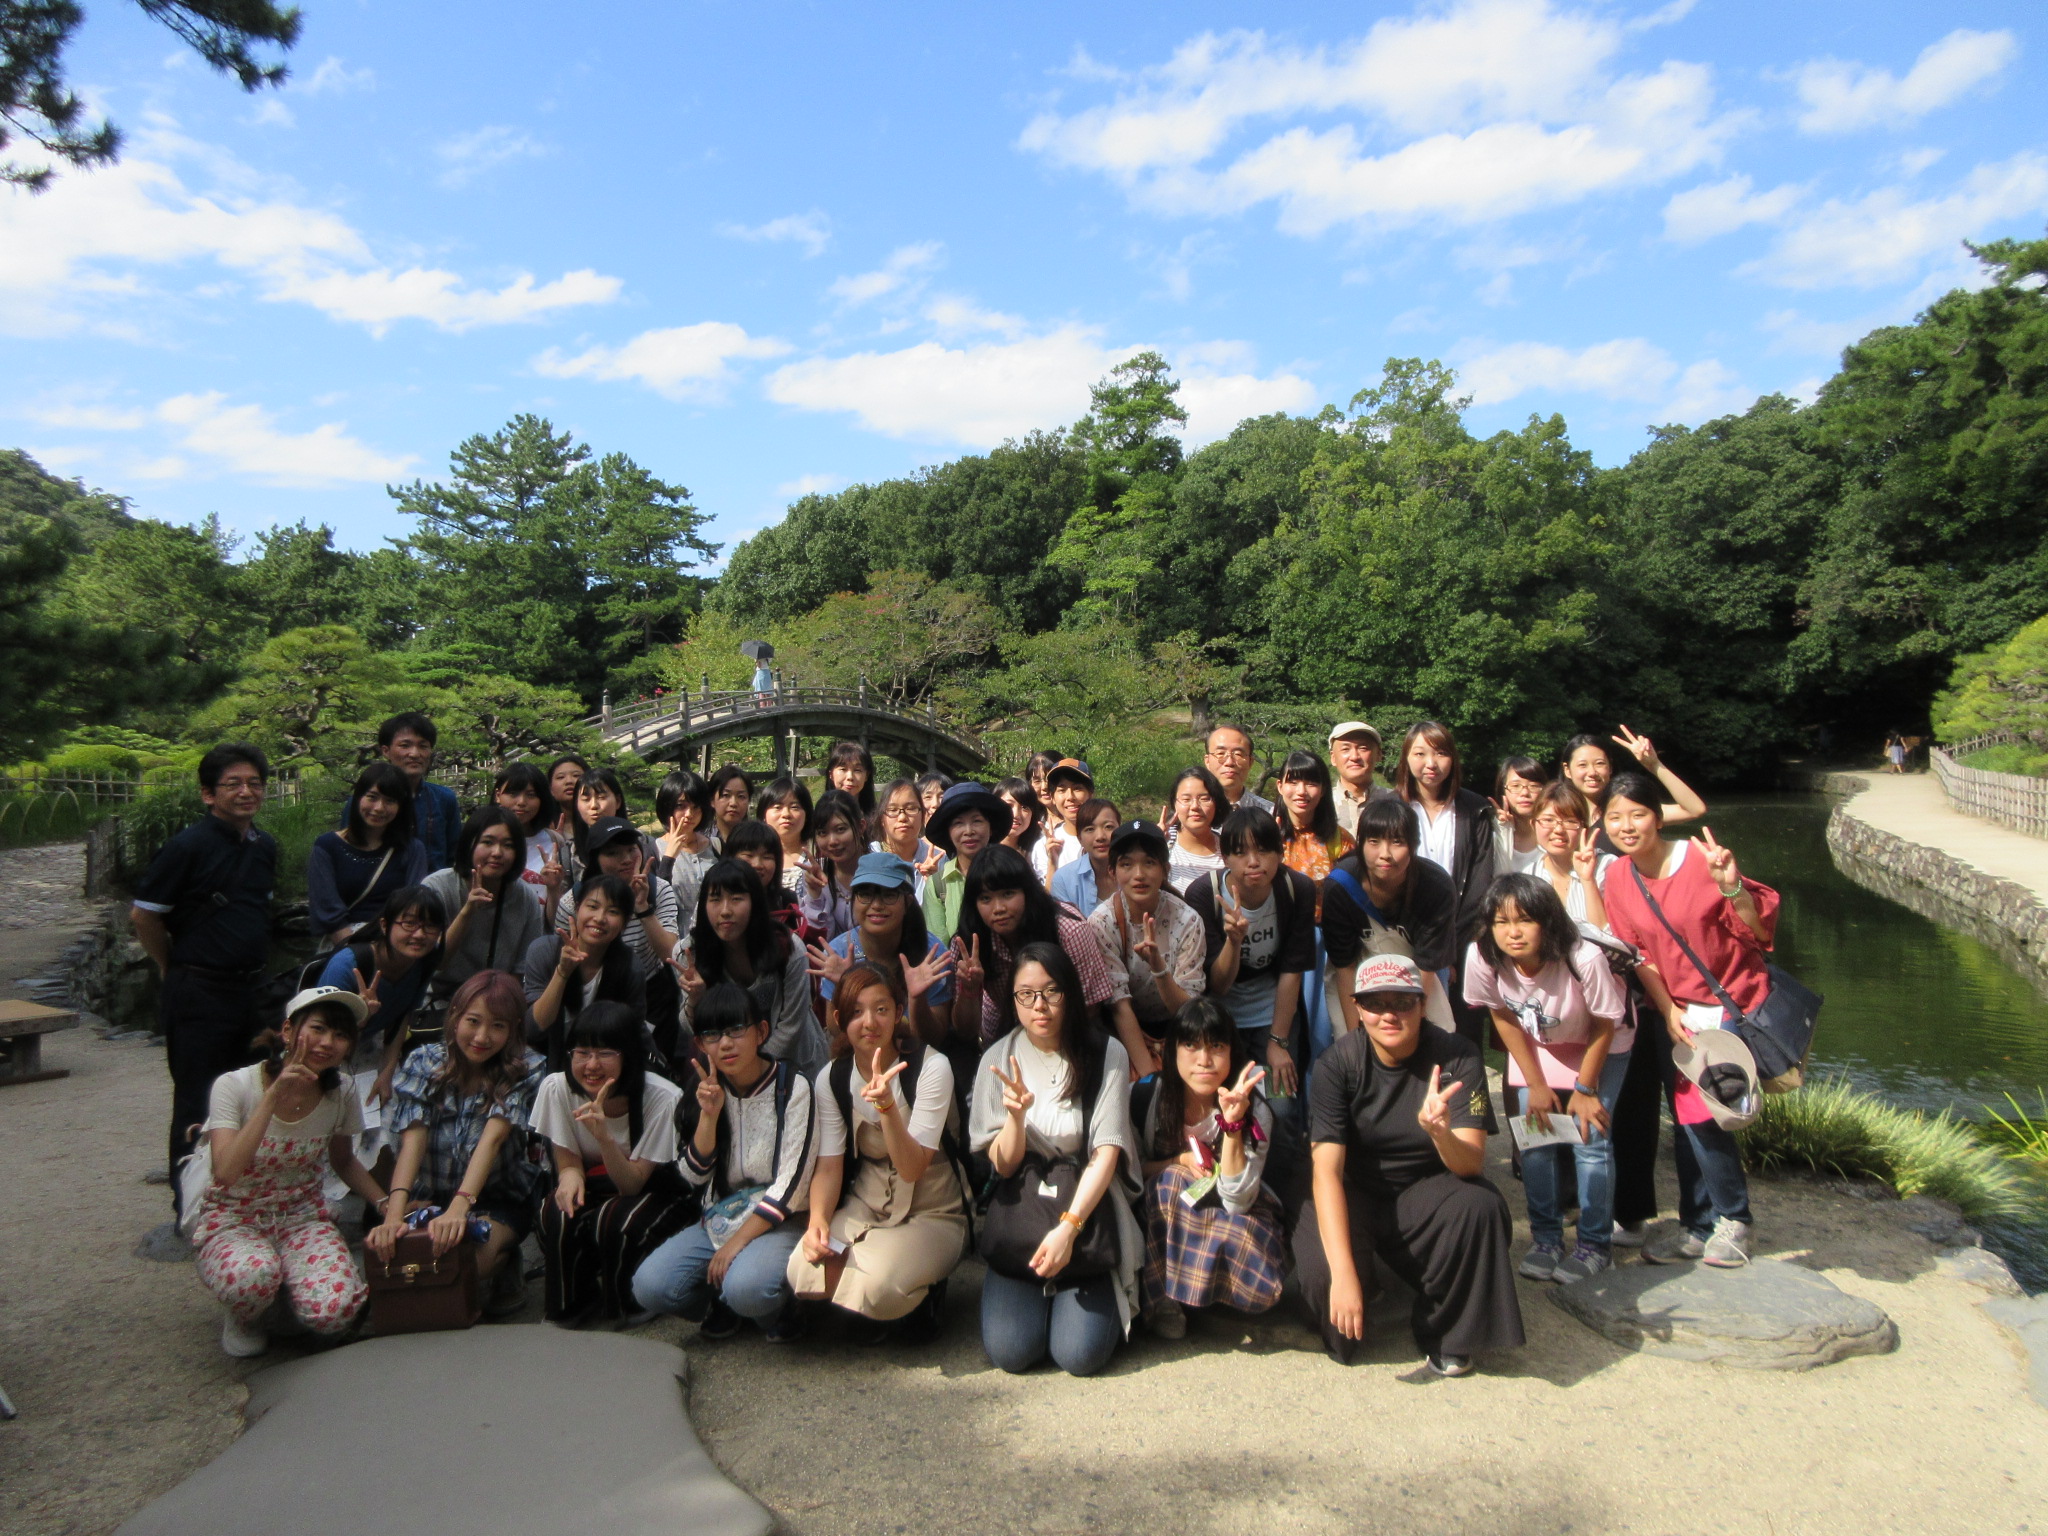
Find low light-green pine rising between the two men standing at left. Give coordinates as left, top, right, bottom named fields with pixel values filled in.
left=190, top=625, right=428, bottom=772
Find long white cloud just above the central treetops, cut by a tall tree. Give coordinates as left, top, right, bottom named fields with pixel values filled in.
left=768, top=324, right=1317, bottom=449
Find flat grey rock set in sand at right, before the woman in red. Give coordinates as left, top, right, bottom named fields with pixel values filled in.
left=1550, top=1260, right=1898, bottom=1370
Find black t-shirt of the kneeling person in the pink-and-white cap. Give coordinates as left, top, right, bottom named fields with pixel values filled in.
left=1309, top=1022, right=1493, bottom=1194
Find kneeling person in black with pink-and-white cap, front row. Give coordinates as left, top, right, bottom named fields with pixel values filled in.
left=1294, top=954, right=1522, bottom=1376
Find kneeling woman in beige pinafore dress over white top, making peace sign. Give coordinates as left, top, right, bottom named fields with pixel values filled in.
left=788, top=965, right=967, bottom=1337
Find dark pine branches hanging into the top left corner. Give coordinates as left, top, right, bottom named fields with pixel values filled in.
left=0, top=0, right=299, bottom=193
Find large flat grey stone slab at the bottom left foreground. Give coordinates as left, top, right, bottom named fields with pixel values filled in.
left=117, top=1325, right=774, bottom=1536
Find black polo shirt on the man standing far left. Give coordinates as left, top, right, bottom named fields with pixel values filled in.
left=135, top=815, right=276, bottom=971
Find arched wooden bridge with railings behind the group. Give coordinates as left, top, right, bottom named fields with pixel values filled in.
left=584, top=678, right=987, bottom=776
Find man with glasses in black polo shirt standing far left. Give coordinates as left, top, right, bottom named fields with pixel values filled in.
left=129, top=741, right=276, bottom=1204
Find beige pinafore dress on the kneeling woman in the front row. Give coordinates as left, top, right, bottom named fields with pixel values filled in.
left=788, top=1053, right=967, bottom=1323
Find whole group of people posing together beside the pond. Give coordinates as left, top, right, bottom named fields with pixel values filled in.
left=133, top=715, right=1778, bottom=1376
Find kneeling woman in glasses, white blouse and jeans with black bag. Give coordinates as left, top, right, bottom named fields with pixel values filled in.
left=969, top=944, right=1145, bottom=1376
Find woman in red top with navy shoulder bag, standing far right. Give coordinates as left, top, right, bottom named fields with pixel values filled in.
left=1602, top=774, right=1778, bottom=1270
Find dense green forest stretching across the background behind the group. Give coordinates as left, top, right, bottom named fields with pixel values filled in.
left=0, top=242, right=2048, bottom=793
